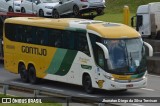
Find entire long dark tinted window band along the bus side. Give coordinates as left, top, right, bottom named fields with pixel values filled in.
left=5, top=24, right=90, bottom=56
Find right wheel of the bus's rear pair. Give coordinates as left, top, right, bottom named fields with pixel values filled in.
left=28, top=66, right=38, bottom=84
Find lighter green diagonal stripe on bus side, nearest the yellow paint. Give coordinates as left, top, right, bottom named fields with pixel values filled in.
left=46, top=49, right=67, bottom=74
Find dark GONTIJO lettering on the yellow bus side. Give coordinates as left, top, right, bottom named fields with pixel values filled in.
left=21, top=46, right=47, bottom=56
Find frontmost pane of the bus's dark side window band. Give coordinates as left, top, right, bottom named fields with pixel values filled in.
left=77, top=32, right=90, bottom=56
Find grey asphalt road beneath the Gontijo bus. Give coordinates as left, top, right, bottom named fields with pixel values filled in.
left=0, top=64, right=160, bottom=106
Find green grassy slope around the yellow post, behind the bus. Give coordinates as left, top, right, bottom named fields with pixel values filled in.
left=94, top=0, right=160, bottom=23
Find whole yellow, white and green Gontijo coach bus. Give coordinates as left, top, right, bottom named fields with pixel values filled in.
left=3, top=17, right=153, bottom=93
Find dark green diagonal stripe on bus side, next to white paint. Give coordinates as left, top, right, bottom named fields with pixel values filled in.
left=55, top=50, right=77, bottom=76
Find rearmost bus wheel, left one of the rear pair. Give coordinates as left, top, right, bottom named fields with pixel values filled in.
left=18, top=64, right=29, bottom=82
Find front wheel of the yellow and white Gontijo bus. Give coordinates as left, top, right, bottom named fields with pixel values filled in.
left=83, top=75, right=93, bottom=93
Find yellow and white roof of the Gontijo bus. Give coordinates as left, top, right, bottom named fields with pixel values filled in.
left=5, top=17, right=140, bottom=39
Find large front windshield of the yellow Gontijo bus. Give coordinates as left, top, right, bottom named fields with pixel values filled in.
left=102, top=38, right=146, bottom=74
